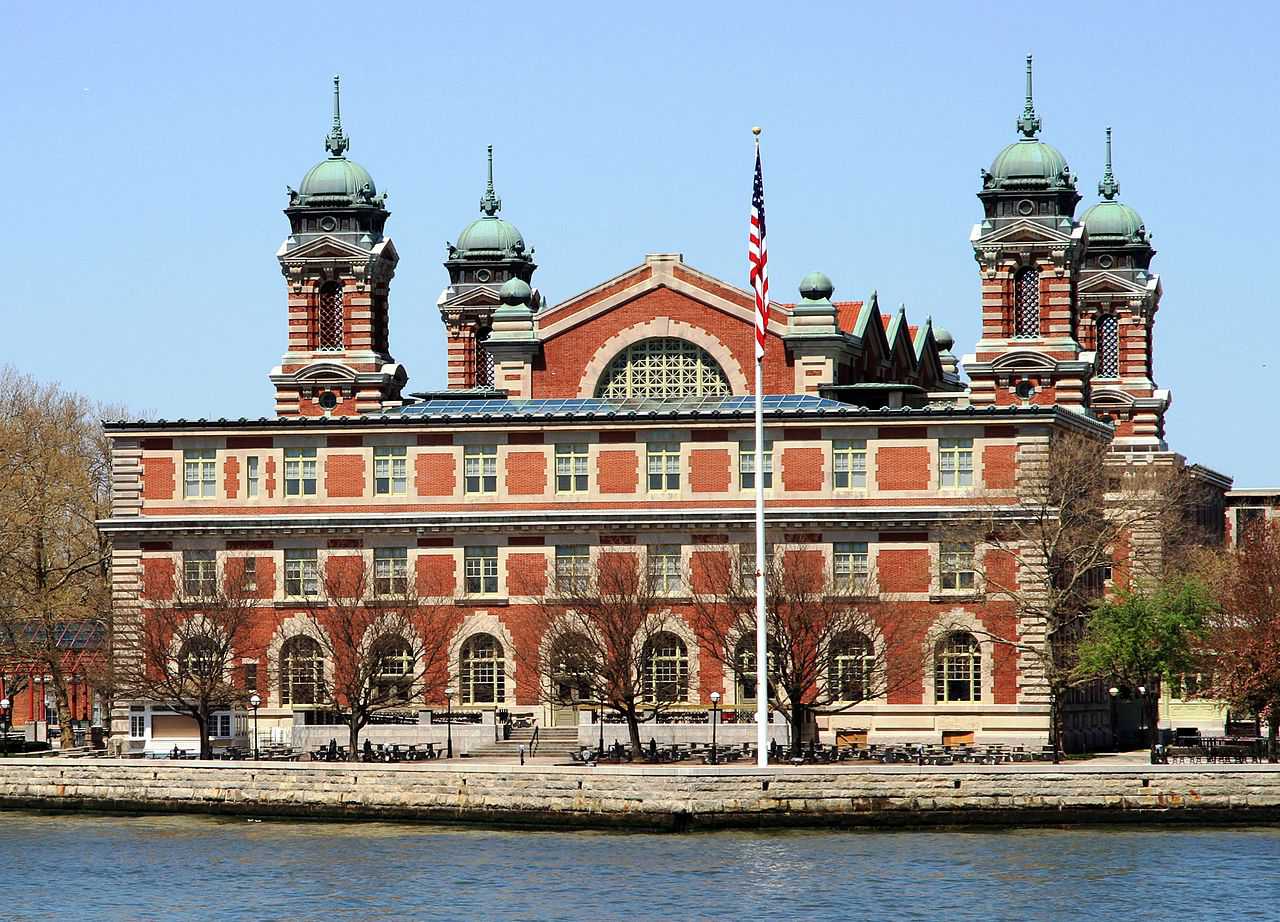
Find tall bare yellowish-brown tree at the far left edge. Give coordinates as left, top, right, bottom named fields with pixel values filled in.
left=0, top=369, right=110, bottom=748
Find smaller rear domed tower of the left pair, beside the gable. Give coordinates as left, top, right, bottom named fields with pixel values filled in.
left=436, top=145, right=541, bottom=389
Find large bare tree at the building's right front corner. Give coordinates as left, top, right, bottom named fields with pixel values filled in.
left=962, top=430, right=1198, bottom=759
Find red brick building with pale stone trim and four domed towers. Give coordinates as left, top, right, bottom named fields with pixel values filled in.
left=102, top=65, right=1228, bottom=748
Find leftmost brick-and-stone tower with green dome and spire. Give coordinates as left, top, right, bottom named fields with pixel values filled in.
left=270, top=77, right=408, bottom=416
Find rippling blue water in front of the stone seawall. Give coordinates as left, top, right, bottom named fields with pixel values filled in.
left=0, top=813, right=1280, bottom=922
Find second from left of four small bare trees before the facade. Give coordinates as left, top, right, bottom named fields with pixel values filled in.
left=285, top=554, right=456, bottom=762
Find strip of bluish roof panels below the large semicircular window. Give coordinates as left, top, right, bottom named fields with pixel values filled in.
left=401, top=394, right=855, bottom=417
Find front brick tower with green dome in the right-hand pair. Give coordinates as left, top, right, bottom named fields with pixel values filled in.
left=964, top=55, right=1092, bottom=412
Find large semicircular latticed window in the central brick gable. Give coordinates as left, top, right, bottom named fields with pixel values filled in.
left=595, top=337, right=731, bottom=401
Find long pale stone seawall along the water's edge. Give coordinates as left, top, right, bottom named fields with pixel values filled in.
left=0, top=758, right=1280, bottom=830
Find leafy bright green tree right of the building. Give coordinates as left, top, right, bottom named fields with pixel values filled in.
left=1075, top=576, right=1217, bottom=741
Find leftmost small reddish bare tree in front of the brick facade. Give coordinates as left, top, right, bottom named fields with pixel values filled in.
left=114, top=560, right=259, bottom=758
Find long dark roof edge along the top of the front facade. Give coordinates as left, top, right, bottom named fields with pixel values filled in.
left=102, top=405, right=1112, bottom=435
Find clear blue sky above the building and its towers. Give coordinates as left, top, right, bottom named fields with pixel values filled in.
left=0, top=0, right=1280, bottom=485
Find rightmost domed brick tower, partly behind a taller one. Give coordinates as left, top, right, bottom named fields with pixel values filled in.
left=1078, top=128, right=1171, bottom=451
